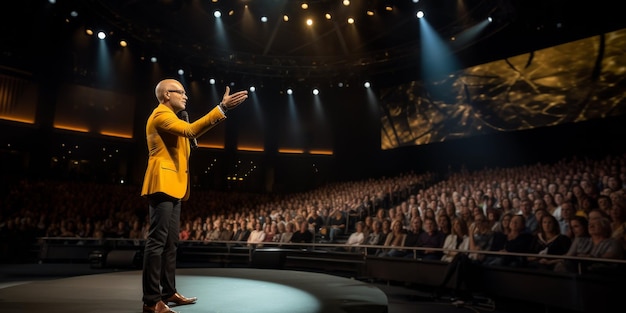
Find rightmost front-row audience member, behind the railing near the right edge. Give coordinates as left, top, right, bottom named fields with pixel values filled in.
left=554, top=218, right=624, bottom=273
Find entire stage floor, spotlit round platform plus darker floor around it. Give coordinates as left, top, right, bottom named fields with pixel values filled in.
left=0, top=264, right=544, bottom=313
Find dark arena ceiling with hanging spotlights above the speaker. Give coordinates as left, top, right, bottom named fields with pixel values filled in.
left=2, top=0, right=626, bottom=88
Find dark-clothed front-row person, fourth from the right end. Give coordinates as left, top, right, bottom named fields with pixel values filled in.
left=483, top=215, right=533, bottom=267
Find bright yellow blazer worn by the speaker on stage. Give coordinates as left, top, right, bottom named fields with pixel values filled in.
left=141, top=103, right=226, bottom=200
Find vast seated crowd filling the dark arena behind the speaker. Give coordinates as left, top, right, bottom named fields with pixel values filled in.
left=0, top=155, right=626, bottom=280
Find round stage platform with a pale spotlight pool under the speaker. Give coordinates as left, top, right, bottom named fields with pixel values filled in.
left=0, top=268, right=388, bottom=313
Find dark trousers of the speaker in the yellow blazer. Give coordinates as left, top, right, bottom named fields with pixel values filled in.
left=142, top=193, right=180, bottom=305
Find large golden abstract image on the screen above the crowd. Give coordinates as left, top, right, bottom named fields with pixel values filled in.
left=380, top=29, right=626, bottom=149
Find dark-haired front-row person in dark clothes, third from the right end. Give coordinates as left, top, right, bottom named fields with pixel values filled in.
left=528, top=214, right=572, bottom=270
